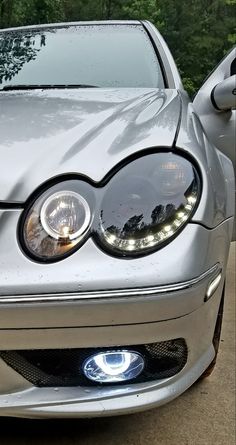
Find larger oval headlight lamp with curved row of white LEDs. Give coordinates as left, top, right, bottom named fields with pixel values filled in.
left=98, top=153, right=200, bottom=256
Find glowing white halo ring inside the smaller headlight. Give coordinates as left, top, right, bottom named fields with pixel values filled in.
left=40, top=190, right=91, bottom=241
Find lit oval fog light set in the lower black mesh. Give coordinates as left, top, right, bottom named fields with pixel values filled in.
left=83, top=351, right=144, bottom=383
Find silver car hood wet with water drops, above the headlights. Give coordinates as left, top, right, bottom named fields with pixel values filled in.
left=0, top=88, right=180, bottom=202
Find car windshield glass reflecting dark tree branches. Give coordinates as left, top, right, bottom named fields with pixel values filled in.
left=0, top=25, right=164, bottom=89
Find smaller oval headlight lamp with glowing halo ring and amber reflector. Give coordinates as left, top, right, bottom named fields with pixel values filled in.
left=21, top=181, right=92, bottom=261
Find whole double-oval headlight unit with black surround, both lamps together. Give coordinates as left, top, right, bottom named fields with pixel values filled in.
left=19, top=152, right=201, bottom=262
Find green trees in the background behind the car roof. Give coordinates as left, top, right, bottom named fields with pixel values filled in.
left=0, top=0, right=236, bottom=95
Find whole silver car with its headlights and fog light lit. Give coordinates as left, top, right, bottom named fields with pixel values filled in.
left=0, top=21, right=236, bottom=418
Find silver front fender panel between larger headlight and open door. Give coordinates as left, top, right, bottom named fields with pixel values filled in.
left=176, top=93, right=235, bottom=228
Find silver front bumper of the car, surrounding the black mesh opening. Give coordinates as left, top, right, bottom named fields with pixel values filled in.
left=0, top=212, right=232, bottom=417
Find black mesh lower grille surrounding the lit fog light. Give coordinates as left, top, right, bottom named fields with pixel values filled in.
left=0, top=338, right=188, bottom=387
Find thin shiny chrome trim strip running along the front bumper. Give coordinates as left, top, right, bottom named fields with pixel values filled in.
left=0, top=263, right=221, bottom=305
